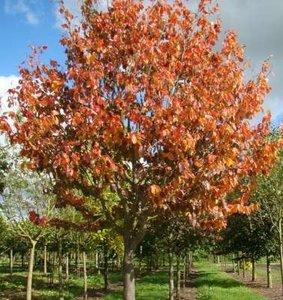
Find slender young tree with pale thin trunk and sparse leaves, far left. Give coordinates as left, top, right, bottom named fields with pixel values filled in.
left=0, top=149, right=54, bottom=300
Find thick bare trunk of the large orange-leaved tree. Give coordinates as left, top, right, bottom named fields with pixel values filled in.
left=123, top=237, right=136, bottom=300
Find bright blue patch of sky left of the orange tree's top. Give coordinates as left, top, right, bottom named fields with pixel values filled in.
left=0, top=0, right=63, bottom=76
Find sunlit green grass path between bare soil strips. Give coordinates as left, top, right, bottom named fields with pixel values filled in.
left=196, top=262, right=266, bottom=300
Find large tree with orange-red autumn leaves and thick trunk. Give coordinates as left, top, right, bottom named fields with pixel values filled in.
left=1, top=0, right=282, bottom=300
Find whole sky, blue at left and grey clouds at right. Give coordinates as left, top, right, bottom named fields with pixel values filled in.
left=0, top=0, right=283, bottom=125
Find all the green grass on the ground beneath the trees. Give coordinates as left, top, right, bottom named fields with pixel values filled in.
left=0, top=262, right=272, bottom=300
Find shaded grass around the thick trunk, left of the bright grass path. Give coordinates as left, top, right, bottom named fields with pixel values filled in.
left=0, top=268, right=168, bottom=300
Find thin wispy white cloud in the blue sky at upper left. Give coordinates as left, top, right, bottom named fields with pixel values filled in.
left=4, top=0, right=39, bottom=25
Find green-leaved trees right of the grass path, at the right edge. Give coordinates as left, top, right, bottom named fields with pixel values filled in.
left=217, top=151, right=283, bottom=292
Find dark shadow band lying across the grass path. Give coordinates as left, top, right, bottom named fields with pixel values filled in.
left=197, top=271, right=243, bottom=289
